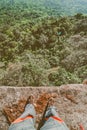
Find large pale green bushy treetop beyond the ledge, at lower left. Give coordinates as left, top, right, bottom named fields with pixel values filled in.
left=2, top=53, right=50, bottom=86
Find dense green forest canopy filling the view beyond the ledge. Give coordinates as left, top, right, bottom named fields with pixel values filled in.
left=0, top=0, right=87, bottom=86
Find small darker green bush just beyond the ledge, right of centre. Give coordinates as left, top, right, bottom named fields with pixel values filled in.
left=48, top=68, right=81, bottom=86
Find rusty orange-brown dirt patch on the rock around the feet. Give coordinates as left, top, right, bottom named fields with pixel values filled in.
left=3, top=93, right=57, bottom=124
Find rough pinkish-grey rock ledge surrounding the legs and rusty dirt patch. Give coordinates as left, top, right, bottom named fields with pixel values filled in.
left=0, top=84, right=87, bottom=130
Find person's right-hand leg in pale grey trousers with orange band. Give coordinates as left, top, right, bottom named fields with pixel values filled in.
left=40, top=98, right=69, bottom=130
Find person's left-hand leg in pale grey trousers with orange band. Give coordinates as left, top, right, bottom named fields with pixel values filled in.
left=9, top=95, right=36, bottom=130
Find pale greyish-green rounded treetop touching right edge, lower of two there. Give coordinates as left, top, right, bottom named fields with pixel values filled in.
left=61, top=50, right=87, bottom=72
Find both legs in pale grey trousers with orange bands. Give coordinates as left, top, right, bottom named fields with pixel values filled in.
left=9, top=96, right=69, bottom=130
